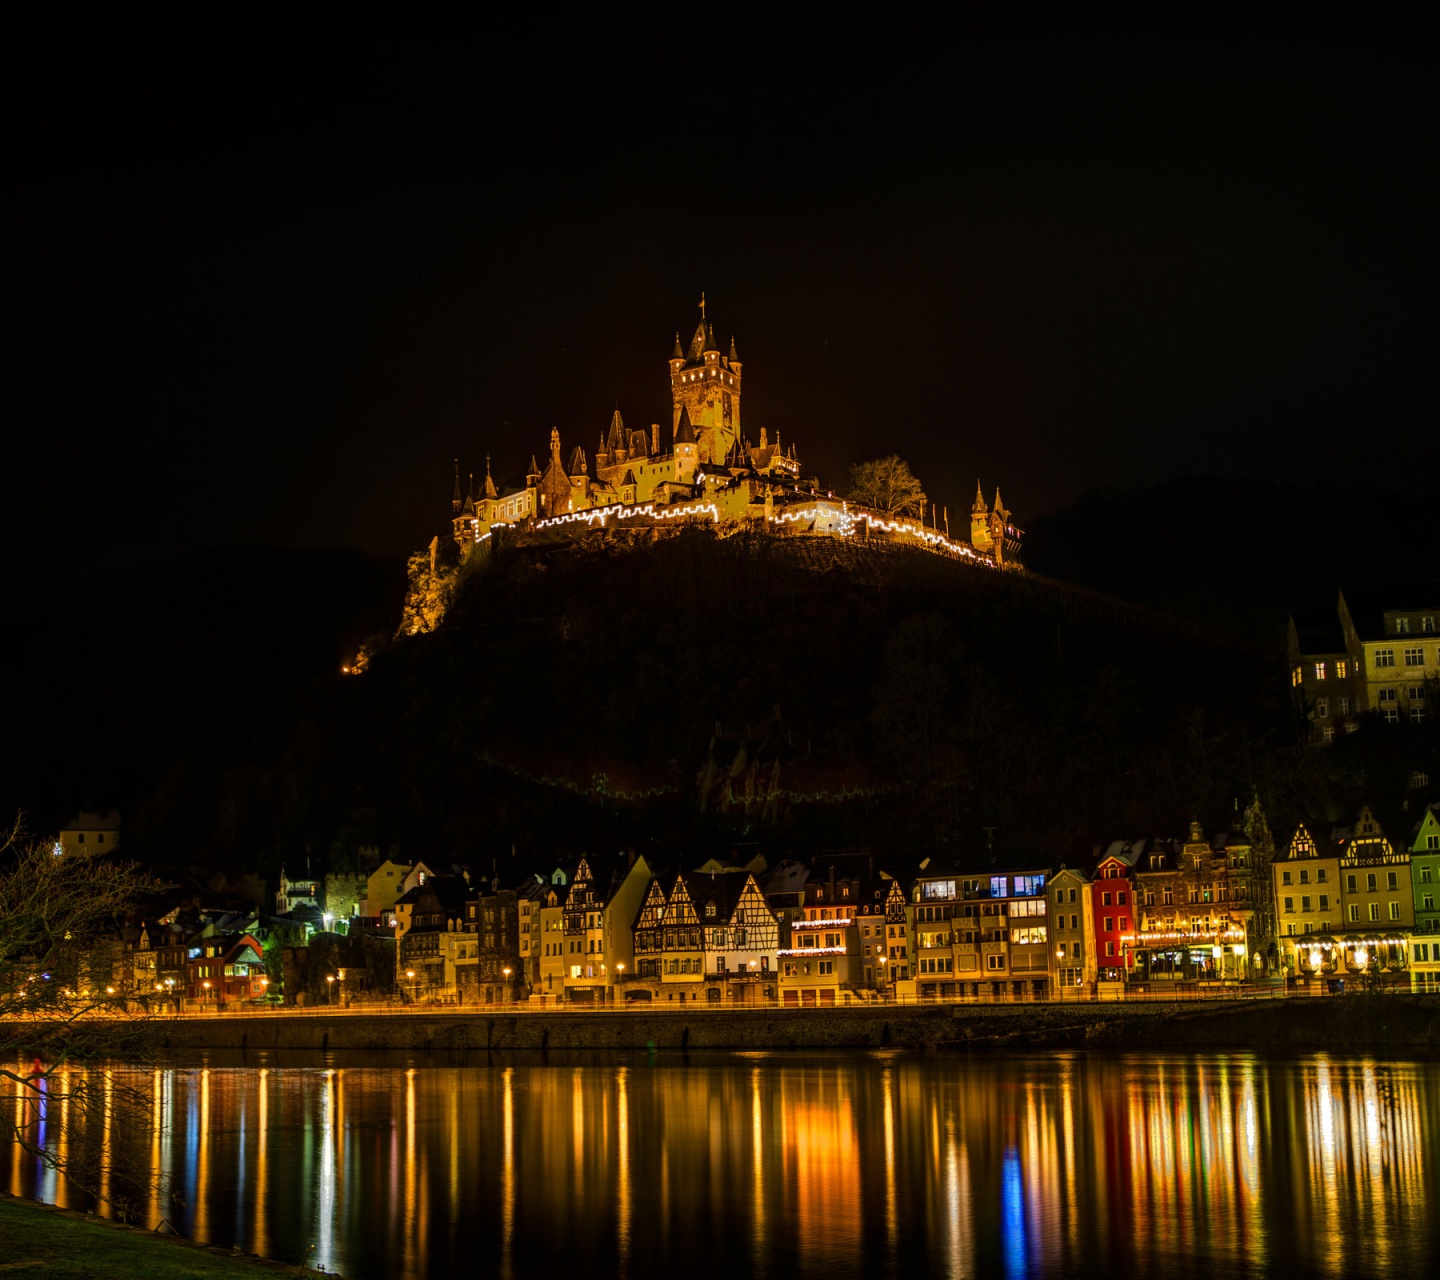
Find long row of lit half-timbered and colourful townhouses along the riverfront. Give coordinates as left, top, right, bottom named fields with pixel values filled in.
left=395, top=809, right=1440, bottom=1008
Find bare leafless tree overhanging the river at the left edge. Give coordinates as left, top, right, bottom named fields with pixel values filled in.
left=0, top=822, right=160, bottom=1214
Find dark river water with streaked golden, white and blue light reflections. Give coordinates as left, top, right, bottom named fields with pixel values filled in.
left=0, top=1054, right=1440, bottom=1280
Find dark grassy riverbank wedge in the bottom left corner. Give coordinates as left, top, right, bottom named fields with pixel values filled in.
left=0, top=1194, right=315, bottom=1280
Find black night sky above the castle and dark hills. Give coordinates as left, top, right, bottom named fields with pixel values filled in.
left=0, top=9, right=1434, bottom=615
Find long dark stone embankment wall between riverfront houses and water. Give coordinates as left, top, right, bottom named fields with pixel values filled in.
left=143, top=995, right=1440, bottom=1053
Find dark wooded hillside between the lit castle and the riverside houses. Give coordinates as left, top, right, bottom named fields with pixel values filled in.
left=4, top=498, right=1440, bottom=877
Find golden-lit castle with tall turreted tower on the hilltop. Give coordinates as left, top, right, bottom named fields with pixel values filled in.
left=403, top=301, right=1022, bottom=629
